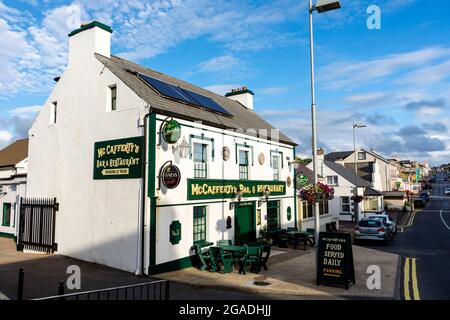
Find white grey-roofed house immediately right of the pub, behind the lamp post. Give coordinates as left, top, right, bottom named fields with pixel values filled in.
left=308, top=149, right=384, bottom=221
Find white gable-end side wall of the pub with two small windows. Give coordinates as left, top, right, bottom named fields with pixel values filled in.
left=27, top=28, right=145, bottom=272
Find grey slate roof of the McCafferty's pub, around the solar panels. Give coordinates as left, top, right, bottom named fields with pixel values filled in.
left=95, top=54, right=296, bottom=145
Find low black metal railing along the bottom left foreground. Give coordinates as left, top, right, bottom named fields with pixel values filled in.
left=33, top=280, right=170, bottom=301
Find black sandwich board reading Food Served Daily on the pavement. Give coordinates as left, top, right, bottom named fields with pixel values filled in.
left=317, top=232, right=355, bottom=290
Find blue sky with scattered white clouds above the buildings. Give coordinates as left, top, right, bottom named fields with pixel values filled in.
left=0, top=0, right=450, bottom=164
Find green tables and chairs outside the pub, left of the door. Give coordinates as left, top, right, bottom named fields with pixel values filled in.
left=191, top=240, right=271, bottom=275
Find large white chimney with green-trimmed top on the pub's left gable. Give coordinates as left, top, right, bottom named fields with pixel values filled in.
left=69, top=21, right=112, bottom=66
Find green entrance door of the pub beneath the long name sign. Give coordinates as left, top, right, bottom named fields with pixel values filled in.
left=234, top=202, right=256, bottom=244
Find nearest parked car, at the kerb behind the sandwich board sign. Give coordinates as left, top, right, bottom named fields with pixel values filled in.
left=353, top=218, right=392, bottom=245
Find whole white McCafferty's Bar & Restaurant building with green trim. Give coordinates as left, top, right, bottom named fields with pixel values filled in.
left=27, top=21, right=297, bottom=274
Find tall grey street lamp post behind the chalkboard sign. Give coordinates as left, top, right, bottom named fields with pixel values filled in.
left=309, top=0, right=341, bottom=244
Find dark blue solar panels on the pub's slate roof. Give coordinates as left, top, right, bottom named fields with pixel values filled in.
left=138, top=73, right=233, bottom=116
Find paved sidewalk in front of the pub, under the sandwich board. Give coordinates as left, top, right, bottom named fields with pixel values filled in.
left=156, top=246, right=399, bottom=299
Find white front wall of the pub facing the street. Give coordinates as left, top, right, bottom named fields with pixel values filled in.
left=156, top=116, right=295, bottom=264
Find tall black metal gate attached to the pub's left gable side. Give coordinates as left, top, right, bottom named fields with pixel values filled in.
left=17, top=198, right=59, bottom=253
